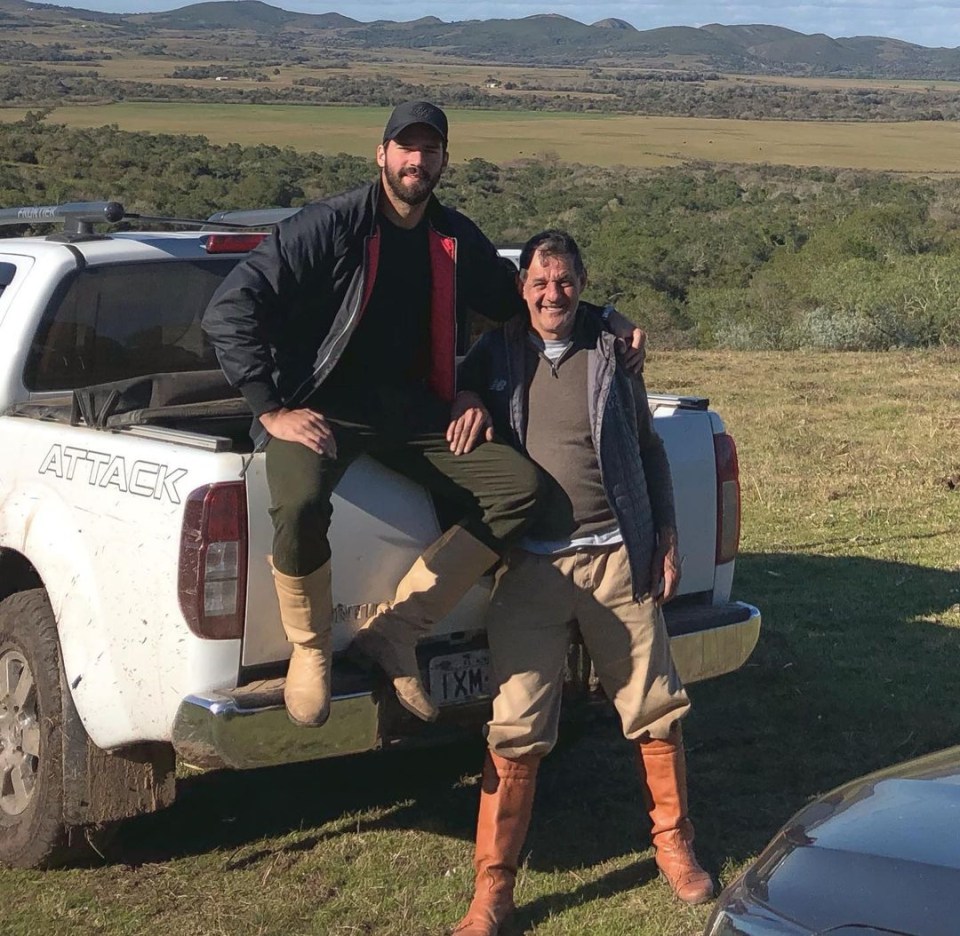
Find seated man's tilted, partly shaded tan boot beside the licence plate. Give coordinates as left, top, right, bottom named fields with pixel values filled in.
left=353, top=526, right=499, bottom=721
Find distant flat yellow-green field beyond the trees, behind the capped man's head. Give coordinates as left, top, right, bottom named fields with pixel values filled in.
left=0, top=104, right=960, bottom=175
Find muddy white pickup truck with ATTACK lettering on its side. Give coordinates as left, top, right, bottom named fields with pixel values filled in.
left=0, top=202, right=760, bottom=867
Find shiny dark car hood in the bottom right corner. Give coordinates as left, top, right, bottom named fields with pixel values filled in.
left=738, top=747, right=960, bottom=936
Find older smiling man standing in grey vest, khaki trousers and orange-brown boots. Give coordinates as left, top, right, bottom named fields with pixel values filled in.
left=450, top=231, right=714, bottom=936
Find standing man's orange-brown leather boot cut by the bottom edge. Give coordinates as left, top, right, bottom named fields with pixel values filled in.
left=452, top=751, right=541, bottom=936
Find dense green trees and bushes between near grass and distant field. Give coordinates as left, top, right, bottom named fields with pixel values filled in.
left=0, top=112, right=960, bottom=350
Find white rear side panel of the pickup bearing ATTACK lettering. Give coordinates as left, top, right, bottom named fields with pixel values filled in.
left=0, top=417, right=248, bottom=748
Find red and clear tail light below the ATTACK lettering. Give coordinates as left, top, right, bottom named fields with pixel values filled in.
left=178, top=481, right=247, bottom=640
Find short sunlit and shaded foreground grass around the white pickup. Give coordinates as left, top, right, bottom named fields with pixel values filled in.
left=0, top=349, right=960, bottom=936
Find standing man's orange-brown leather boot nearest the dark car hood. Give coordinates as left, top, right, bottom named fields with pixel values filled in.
left=636, top=726, right=714, bottom=904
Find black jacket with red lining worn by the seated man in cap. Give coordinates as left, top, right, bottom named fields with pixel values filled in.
left=203, top=180, right=523, bottom=434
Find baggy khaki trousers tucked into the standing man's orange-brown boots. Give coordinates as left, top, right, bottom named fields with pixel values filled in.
left=486, top=545, right=690, bottom=758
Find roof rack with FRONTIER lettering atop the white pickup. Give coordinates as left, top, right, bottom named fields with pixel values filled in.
left=0, top=201, right=300, bottom=240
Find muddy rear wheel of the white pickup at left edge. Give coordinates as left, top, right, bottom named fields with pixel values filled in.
left=0, top=589, right=67, bottom=868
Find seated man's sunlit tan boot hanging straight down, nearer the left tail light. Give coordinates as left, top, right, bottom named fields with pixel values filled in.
left=273, top=562, right=333, bottom=726
